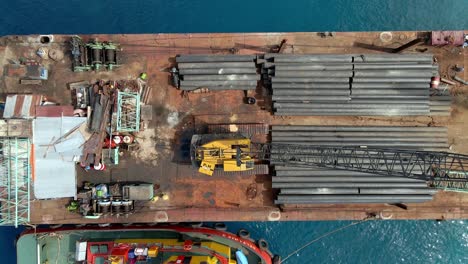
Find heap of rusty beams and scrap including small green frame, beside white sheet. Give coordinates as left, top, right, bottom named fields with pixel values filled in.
left=70, top=80, right=141, bottom=170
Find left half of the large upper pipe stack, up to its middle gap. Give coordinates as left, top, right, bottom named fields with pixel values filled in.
left=263, top=54, right=353, bottom=111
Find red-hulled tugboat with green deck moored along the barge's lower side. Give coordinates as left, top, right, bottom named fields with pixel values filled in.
left=16, top=223, right=281, bottom=264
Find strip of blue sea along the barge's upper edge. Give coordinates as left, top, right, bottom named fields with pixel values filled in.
left=0, top=0, right=468, bottom=35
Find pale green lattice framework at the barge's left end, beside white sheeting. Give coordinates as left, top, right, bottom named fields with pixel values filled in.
left=0, top=137, right=31, bottom=227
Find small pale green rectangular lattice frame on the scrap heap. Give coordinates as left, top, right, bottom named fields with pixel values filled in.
left=117, top=92, right=140, bottom=132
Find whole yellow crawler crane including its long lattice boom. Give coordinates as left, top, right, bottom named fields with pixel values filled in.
left=191, top=135, right=468, bottom=192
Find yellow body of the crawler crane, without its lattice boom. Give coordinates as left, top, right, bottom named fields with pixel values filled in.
left=190, top=134, right=255, bottom=176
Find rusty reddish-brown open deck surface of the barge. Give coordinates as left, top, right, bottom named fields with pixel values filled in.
left=0, top=32, right=468, bottom=224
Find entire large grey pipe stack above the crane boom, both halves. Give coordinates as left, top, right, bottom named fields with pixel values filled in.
left=263, top=54, right=446, bottom=116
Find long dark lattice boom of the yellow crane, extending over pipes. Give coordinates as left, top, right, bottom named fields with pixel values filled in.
left=262, top=144, right=468, bottom=192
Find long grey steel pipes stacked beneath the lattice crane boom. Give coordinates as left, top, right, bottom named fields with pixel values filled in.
left=271, top=126, right=448, bottom=205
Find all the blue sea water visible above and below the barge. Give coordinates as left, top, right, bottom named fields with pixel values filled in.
left=0, top=0, right=468, bottom=263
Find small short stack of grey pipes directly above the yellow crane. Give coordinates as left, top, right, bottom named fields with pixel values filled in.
left=176, top=55, right=260, bottom=91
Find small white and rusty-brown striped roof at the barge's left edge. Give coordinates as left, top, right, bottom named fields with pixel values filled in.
left=3, top=94, right=42, bottom=119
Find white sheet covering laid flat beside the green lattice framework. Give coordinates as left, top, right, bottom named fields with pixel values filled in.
left=33, top=117, right=86, bottom=199
